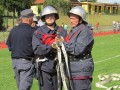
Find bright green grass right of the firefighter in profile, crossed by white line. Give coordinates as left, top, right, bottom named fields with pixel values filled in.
left=92, top=35, right=120, bottom=90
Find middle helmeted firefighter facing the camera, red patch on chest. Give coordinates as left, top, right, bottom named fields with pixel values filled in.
left=32, top=6, right=67, bottom=90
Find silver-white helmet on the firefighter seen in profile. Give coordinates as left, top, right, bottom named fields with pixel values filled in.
left=68, top=6, right=86, bottom=22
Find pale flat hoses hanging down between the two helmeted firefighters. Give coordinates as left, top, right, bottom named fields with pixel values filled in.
left=57, top=42, right=74, bottom=90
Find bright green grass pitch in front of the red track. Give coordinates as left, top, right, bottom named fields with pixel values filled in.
left=0, top=34, right=120, bottom=90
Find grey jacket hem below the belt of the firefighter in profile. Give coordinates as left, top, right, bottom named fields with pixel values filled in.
left=70, top=58, right=94, bottom=76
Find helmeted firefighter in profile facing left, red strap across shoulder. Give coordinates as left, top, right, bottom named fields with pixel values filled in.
left=64, top=6, right=94, bottom=90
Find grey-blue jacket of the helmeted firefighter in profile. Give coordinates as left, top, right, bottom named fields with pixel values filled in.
left=64, top=24, right=94, bottom=76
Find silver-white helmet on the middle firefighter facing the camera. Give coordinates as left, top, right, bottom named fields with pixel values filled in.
left=41, top=6, right=59, bottom=21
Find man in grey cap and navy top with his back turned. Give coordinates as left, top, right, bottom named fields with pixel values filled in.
left=6, top=9, right=35, bottom=90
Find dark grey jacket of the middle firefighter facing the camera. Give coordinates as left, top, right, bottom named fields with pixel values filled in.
left=32, top=25, right=67, bottom=73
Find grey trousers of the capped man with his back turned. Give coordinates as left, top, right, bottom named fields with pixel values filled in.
left=12, top=59, right=34, bottom=90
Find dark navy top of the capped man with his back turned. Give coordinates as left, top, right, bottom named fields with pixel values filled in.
left=6, top=23, right=34, bottom=60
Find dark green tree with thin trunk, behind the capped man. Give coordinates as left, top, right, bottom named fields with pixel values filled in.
left=0, top=0, right=35, bottom=26
